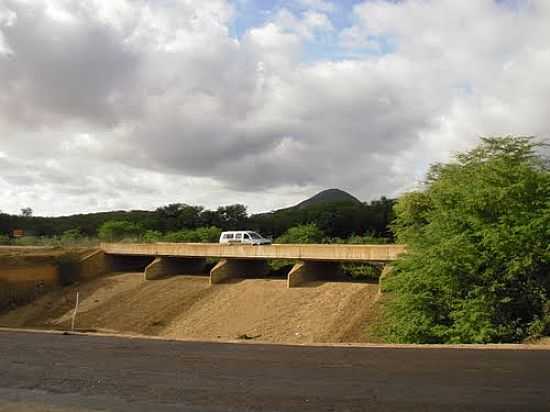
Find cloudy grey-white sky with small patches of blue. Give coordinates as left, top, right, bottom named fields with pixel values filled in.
left=0, top=0, right=550, bottom=215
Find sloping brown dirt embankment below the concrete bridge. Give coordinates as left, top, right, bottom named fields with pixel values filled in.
left=0, top=273, right=386, bottom=343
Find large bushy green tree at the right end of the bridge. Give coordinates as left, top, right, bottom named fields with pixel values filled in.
left=385, top=137, right=550, bottom=343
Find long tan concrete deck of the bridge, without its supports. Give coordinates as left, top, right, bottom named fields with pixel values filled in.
left=101, top=243, right=406, bottom=262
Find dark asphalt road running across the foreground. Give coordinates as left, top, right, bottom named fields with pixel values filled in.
left=0, top=331, right=550, bottom=412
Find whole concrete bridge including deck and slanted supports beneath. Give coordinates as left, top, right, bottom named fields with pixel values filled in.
left=83, top=243, right=406, bottom=287
